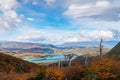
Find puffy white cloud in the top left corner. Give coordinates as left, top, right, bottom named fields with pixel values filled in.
left=0, top=0, right=24, bottom=29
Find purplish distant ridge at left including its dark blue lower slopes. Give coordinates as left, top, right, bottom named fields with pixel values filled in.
left=0, top=41, right=57, bottom=53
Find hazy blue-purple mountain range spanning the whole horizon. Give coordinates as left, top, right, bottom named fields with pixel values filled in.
left=0, top=41, right=119, bottom=53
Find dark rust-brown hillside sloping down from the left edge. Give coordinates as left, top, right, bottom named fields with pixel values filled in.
left=0, top=53, right=40, bottom=74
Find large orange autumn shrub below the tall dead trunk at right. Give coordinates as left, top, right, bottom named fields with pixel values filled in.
left=88, top=57, right=117, bottom=80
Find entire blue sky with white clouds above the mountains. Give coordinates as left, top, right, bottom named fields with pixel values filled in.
left=0, top=0, right=120, bottom=44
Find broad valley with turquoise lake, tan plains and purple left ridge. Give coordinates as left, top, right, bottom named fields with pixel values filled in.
left=0, top=41, right=112, bottom=64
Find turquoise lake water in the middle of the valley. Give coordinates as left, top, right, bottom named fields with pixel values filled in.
left=24, top=54, right=64, bottom=63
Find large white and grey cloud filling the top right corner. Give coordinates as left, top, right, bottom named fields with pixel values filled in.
left=63, top=0, right=120, bottom=21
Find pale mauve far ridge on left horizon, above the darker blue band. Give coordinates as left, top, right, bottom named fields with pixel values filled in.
left=0, top=41, right=55, bottom=49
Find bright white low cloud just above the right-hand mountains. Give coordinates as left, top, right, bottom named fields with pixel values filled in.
left=66, top=30, right=114, bottom=42
